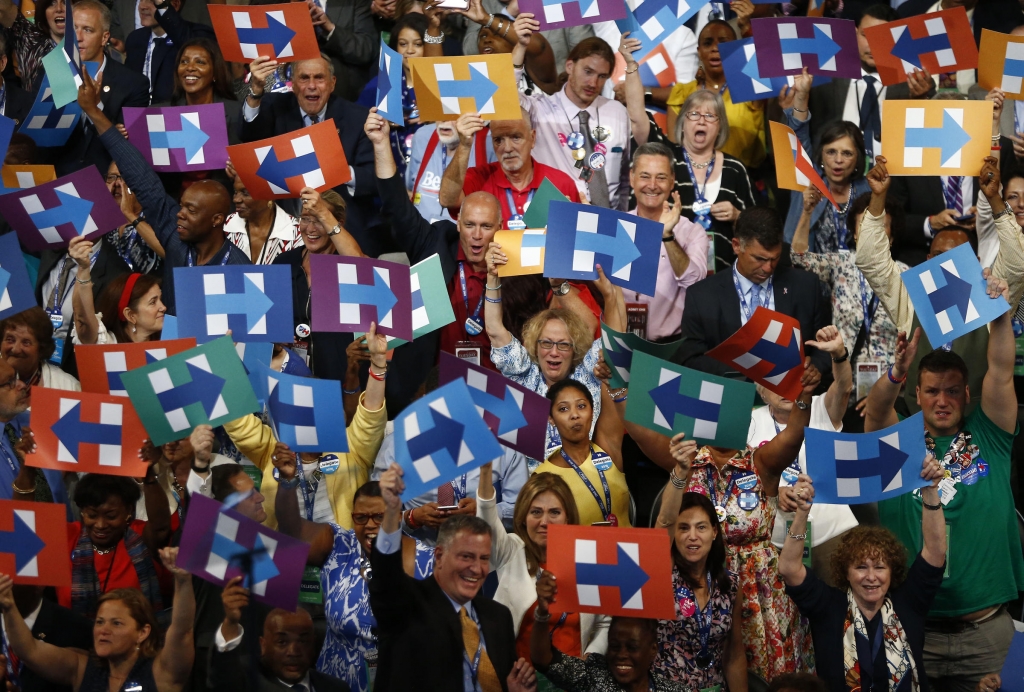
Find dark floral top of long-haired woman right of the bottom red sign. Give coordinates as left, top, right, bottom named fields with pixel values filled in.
left=653, top=566, right=739, bottom=690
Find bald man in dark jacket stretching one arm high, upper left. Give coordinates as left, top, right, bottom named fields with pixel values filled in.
left=78, top=68, right=252, bottom=314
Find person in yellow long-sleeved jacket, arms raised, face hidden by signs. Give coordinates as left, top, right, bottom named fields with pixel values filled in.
left=224, top=325, right=387, bottom=530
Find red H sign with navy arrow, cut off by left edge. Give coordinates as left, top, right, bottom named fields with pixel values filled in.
left=0, top=500, right=71, bottom=587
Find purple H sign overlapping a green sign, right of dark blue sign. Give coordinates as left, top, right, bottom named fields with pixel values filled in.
left=309, top=255, right=413, bottom=341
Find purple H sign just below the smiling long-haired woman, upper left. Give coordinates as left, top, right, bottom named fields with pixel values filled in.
left=124, top=103, right=227, bottom=173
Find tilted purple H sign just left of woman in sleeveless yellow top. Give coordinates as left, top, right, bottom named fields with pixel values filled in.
left=438, top=351, right=551, bottom=459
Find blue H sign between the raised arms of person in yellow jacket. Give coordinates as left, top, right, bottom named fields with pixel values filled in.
left=256, top=364, right=348, bottom=452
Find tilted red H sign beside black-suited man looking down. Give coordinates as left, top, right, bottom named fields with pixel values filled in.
left=708, top=306, right=804, bottom=401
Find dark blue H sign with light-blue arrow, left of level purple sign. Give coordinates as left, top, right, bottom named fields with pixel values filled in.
left=174, top=265, right=294, bottom=344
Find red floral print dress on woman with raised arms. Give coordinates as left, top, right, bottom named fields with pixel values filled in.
left=686, top=447, right=814, bottom=682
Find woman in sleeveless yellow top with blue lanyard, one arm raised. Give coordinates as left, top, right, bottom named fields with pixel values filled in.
left=537, top=380, right=632, bottom=526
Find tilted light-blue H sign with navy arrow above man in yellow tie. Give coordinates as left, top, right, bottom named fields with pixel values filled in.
left=394, top=380, right=504, bottom=499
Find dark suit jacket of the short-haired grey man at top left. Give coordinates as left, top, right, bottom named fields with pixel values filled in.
left=35, top=57, right=150, bottom=176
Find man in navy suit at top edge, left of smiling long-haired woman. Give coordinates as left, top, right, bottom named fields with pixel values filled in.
left=125, top=0, right=216, bottom=103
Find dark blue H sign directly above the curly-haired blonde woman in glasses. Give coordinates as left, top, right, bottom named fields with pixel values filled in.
left=544, top=202, right=664, bottom=296
